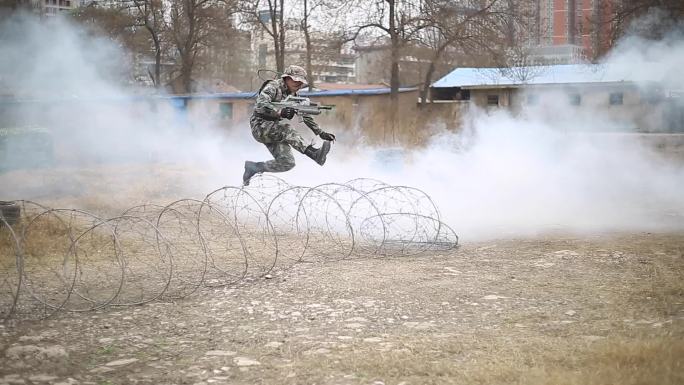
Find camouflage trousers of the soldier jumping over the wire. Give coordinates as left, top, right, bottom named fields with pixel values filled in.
left=250, top=118, right=307, bottom=172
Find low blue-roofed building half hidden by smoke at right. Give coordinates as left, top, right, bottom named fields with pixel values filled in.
left=430, top=64, right=684, bottom=132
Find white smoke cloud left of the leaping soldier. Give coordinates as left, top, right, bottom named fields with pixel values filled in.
left=0, top=14, right=258, bottom=199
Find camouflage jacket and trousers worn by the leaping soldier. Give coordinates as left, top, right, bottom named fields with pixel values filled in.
left=249, top=78, right=322, bottom=172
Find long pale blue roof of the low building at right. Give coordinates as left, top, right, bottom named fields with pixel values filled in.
left=432, top=64, right=653, bottom=88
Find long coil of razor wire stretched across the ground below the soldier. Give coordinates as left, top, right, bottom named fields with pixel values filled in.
left=0, top=175, right=458, bottom=320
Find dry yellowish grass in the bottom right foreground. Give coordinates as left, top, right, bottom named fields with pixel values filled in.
left=266, top=243, right=684, bottom=385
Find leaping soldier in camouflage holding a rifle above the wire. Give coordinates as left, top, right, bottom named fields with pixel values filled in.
left=242, top=65, right=335, bottom=186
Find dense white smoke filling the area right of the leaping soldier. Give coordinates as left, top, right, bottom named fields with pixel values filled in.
left=280, top=25, right=684, bottom=239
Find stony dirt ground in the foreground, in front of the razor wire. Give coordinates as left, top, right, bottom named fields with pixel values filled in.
left=0, top=233, right=684, bottom=385
